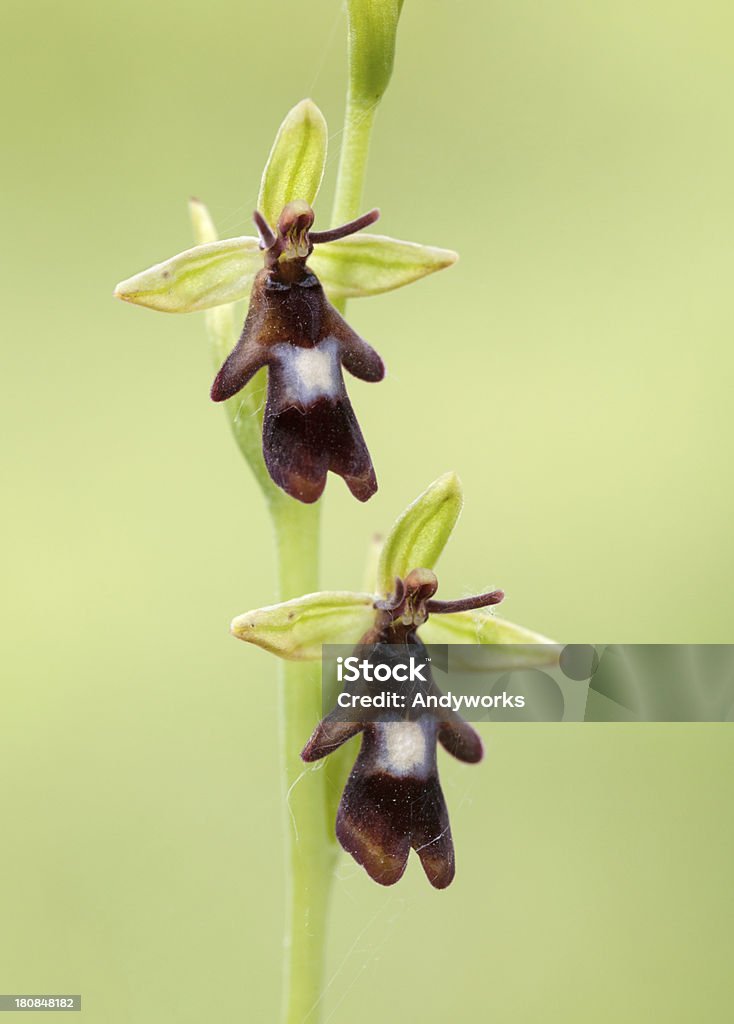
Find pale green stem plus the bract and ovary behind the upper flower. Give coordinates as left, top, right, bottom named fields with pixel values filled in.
left=190, top=195, right=337, bottom=1024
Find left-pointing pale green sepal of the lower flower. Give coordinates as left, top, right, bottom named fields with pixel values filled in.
left=231, top=591, right=375, bottom=662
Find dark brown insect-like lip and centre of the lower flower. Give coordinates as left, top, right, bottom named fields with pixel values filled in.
left=301, top=569, right=504, bottom=889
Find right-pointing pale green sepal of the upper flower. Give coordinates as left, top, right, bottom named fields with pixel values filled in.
left=308, top=234, right=459, bottom=299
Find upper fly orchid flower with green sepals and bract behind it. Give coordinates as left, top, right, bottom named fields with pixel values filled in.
left=115, top=99, right=457, bottom=503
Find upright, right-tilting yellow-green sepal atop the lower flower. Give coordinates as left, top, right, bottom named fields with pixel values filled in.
left=378, top=473, right=464, bottom=594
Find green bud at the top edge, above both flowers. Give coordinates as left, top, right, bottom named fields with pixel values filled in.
left=347, top=0, right=402, bottom=109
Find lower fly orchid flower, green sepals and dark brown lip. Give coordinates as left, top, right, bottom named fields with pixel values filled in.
left=231, top=473, right=555, bottom=889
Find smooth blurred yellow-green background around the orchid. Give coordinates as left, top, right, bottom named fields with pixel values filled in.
left=0, top=0, right=734, bottom=1024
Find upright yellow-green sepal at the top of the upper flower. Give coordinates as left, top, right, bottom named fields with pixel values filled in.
left=257, top=99, right=329, bottom=226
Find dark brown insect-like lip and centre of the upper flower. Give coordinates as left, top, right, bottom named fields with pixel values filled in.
left=211, top=202, right=385, bottom=504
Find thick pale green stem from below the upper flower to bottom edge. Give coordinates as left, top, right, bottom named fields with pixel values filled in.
left=270, top=497, right=337, bottom=1024
